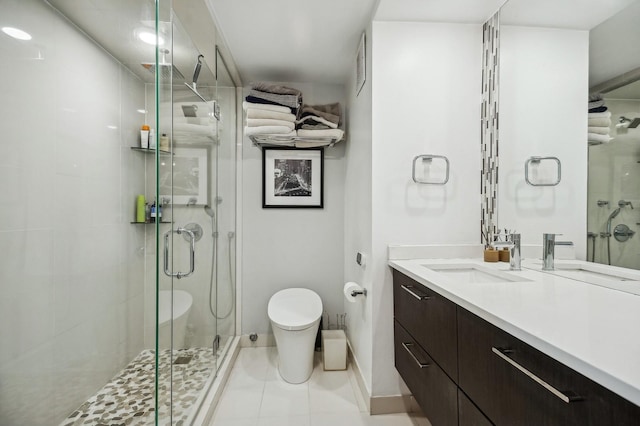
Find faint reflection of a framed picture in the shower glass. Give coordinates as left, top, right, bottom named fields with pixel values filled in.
left=159, top=148, right=208, bottom=205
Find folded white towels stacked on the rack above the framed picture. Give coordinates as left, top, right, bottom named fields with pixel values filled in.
left=242, top=101, right=296, bottom=137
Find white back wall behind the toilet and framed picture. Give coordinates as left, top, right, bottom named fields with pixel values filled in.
left=241, top=83, right=349, bottom=334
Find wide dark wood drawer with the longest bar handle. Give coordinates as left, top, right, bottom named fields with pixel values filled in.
left=458, top=307, right=640, bottom=426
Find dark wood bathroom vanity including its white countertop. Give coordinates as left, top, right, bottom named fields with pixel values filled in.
left=389, top=259, right=640, bottom=426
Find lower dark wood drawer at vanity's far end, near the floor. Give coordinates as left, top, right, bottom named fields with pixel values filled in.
left=394, top=321, right=458, bottom=426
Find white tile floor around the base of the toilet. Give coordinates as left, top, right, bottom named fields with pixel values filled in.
left=209, top=347, right=430, bottom=426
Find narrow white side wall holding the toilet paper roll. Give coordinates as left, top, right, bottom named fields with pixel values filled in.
left=344, top=26, right=373, bottom=392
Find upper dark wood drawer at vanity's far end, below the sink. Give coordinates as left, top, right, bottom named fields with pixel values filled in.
left=393, top=270, right=458, bottom=381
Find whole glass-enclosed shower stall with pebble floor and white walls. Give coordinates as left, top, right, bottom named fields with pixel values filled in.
left=0, top=0, right=237, bottom=425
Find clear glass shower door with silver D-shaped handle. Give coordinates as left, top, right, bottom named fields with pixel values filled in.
left=157, top=13, right=218, bottom=424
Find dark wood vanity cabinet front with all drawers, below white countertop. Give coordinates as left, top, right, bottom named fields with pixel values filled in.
left=393, top=270, right=640, bottom=426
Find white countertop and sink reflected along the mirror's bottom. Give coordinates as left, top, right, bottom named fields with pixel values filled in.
left=523, top=262, right=640, bottom=295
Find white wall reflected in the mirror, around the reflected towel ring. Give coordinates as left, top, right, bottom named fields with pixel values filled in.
left=498, top=26, right=589, bottom=259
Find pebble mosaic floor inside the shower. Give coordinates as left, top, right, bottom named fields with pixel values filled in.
left=60, top=348, right=215, bottom=426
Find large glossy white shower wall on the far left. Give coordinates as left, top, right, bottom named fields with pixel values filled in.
left=0, top=0, right=145, bottom=424
